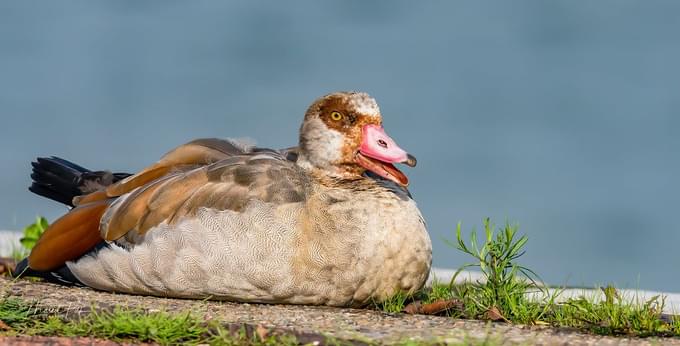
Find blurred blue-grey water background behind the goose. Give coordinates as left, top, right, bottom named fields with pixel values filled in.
left=0, top=0, right=680, bottom=291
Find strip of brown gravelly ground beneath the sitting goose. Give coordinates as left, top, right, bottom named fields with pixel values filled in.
left=0, top=277, right=680, bottom=345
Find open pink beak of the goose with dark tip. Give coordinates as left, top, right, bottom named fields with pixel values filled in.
left=355, top=125, right=417, bottom=186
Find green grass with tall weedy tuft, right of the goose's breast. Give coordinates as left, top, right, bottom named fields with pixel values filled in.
left=374, top=219, right=680, bottom=337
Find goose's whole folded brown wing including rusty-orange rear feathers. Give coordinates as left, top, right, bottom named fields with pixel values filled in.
left=29, top=139, right=306, bottom=270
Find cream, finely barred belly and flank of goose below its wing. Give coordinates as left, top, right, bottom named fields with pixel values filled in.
left=68, top=197, right=431, bottom=305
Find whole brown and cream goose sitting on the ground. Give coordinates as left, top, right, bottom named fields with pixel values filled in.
left=15, top=91, right=432, bottom=307
